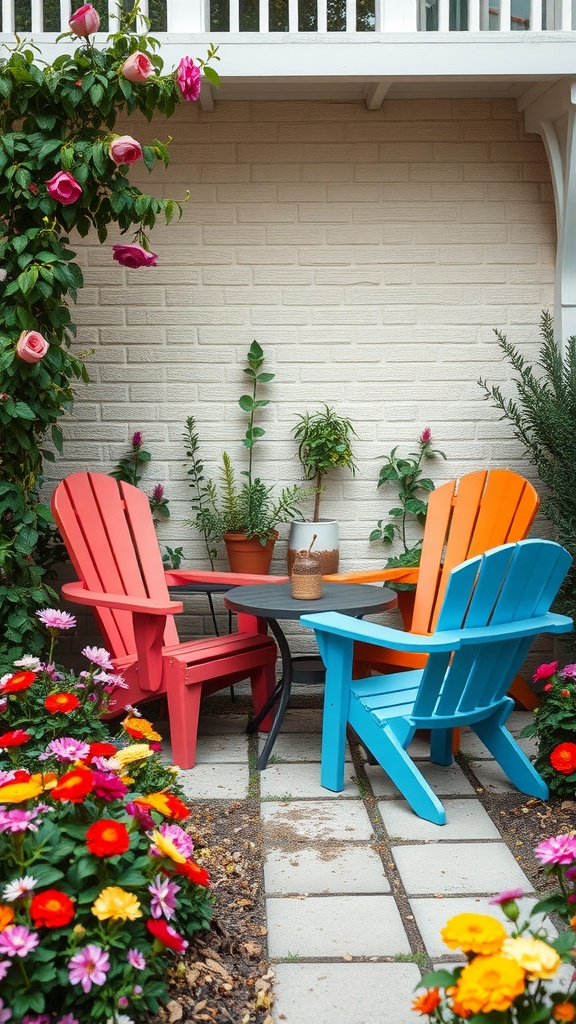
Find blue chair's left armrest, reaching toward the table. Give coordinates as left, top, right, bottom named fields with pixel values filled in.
left=300, top=611, right=464, bottom=653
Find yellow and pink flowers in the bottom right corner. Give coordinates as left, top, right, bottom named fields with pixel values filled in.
left=412, top=836, right=576, bottom=1024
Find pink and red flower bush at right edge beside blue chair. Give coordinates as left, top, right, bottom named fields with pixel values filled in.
left=522, top=662, right=576, bottom=798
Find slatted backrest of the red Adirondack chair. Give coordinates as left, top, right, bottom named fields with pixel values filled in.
left=52, top=473, right=178, bottom=657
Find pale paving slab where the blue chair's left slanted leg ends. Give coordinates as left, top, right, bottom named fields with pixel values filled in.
left=378, top=800, right=500, bottom=839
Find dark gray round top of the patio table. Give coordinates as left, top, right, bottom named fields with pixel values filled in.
left=224, top=583, right=397, bottom=618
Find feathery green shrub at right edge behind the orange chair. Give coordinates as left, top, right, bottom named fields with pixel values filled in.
left=478, top=312, right=576, bottom=652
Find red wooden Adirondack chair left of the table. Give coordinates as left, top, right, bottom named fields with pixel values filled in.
left=52, top=473, right=280, bottom=768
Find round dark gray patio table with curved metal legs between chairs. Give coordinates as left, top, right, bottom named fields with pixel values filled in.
left=223, top=583, right=397, bottom=771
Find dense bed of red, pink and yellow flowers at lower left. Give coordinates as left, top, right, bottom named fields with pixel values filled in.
left=0, top=643, right=211, bottom=1024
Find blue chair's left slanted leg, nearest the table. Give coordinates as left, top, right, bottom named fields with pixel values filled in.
left=344, top=700, right=446, bottom=825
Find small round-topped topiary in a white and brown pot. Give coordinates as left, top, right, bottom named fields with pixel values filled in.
left=288, top=404, right=357, bottom=574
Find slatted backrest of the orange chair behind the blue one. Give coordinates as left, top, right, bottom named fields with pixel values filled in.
left=411, top=469, right=539, bottom=633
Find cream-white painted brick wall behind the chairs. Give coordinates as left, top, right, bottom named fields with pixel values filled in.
left=48, top=99, right=556, bottom=643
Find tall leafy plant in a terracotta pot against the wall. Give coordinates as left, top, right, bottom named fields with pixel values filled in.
left=184, top=341, right=304, bottom=573
